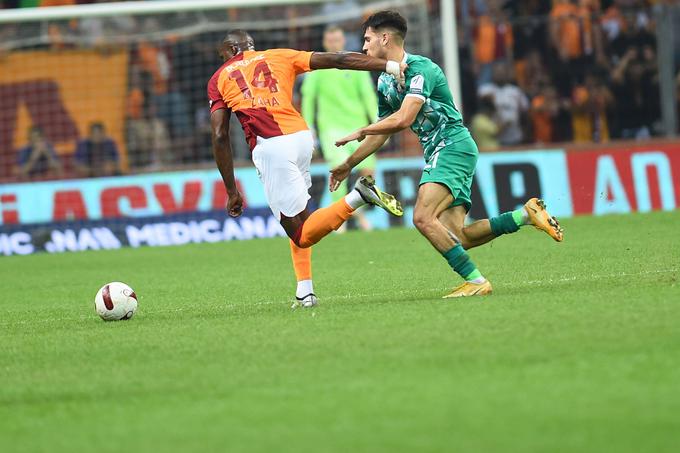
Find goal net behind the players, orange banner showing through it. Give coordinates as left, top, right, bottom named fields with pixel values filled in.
left=0, top=0, right=441, bottom=181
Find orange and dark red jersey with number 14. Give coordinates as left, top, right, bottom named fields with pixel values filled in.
left=208, top=49, right=312, bottom=150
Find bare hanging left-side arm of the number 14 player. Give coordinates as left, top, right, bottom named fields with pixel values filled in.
left=210, top=109, right=243, bottom=217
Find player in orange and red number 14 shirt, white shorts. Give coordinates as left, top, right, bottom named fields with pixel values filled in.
left=208, top=30, right=406, bottom=307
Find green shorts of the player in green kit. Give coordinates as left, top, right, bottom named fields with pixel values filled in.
left=420, top=137, right=479, bottom=211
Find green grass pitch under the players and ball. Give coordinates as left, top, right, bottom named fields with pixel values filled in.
left=0, top=212, right=680, bottom=452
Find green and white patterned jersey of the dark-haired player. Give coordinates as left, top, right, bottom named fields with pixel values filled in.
left=378, top=54, right=470, bottom=162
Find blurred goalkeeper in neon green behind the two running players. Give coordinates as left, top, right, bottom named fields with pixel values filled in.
left=302, top=25, right=378, bottom=230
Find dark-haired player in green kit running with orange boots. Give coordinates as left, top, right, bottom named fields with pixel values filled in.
left=330, top=11, right=562, bottom=298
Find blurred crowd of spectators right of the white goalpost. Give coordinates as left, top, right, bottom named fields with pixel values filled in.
left=460, top=0, right=661, bottom=148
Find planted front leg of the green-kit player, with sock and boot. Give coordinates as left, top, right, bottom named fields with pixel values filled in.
left=413, top=182, right=492, bottom=297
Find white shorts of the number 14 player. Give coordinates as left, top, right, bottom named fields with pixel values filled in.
left=253, top=131, right=314, bottom=220
